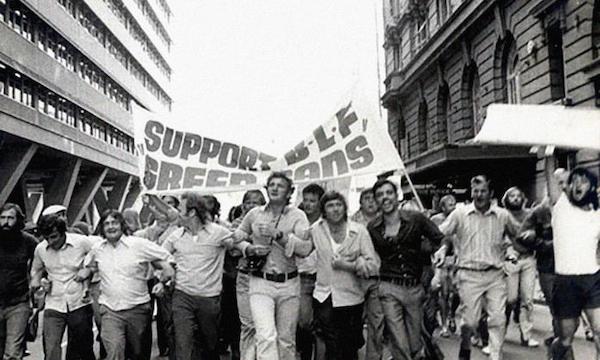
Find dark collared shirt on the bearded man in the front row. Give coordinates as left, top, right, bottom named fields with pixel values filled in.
left=368, top=210, right=444, bottom=280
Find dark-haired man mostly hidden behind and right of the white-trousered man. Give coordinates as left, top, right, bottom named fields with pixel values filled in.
left=296, top=184, right=325, bottom=360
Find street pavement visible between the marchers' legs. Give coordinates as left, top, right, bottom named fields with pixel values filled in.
left=25, top=305, right=595, bottom=360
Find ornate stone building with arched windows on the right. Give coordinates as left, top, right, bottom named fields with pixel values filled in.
left=383, top=0, right=600, bottom=206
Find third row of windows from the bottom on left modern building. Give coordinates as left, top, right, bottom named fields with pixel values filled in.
left=49, top=0, right=171, bottom=109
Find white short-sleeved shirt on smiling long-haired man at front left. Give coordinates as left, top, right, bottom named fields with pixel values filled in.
left=85, top=235, right=169, bottom=311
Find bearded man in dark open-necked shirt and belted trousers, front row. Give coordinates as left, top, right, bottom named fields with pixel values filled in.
left=368, top=180, right=444, bottom=360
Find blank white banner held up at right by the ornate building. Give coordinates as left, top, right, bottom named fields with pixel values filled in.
left=473, top=104, right=600, bottom=151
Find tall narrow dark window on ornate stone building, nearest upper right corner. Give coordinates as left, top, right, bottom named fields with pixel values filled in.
left=546, top=21, right=565, bottom=101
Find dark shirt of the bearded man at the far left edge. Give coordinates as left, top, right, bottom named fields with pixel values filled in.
left=0, top=231, right=38, bottom=306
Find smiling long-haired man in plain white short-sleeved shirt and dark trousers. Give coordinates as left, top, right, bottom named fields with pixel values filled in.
left=78, top=210, right=173, bottom=360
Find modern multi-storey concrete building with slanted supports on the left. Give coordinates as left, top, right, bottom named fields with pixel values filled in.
left=0, top=0, right=172, bottom=223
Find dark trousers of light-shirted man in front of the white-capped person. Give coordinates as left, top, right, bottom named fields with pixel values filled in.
left=43, top=305, right=96, bottom=360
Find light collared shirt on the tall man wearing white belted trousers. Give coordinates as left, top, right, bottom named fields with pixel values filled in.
left=235, top=204, right=309, bottom=274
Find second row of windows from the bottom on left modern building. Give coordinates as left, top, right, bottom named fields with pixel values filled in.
left=0, top=0, right=131, bottom=111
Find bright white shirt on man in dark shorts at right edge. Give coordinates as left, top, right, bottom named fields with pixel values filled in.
left=552, top=193, right=600, bottom=275
